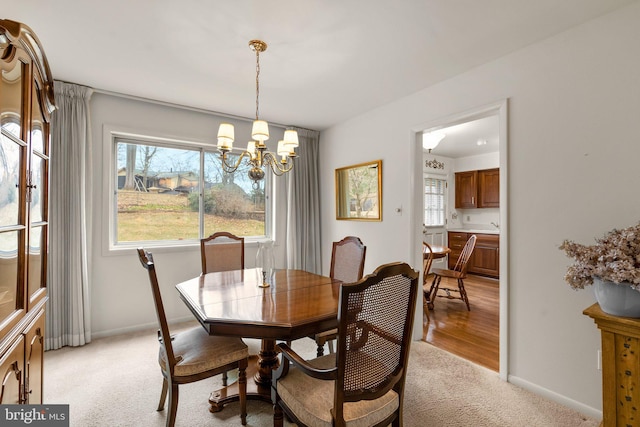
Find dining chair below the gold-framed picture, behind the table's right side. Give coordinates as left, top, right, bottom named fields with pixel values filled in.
left=311, top=236, right=367, bottom=357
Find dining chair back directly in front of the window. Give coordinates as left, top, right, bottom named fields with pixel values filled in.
left=200, top=231, right=244, bottom=274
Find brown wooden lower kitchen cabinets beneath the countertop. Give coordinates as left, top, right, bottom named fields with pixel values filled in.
left=447, top=231, right=500, bottom=279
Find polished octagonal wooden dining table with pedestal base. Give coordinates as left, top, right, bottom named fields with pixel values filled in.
left=176, top=268, right=342, bottom=412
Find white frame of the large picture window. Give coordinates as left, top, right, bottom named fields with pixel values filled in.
left=103, top=125, right=276, bottom=253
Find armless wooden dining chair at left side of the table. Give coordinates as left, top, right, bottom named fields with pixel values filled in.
left=138, top=248, right=249, bottom=427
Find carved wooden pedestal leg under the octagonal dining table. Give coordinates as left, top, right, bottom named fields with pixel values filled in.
left=209, top=340, right=280, bottom=412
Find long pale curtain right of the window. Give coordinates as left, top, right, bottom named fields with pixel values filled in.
left=287, top=129, right=322, bottom=274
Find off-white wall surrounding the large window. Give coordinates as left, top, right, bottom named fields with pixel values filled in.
left=90, top=93, right=286, bottom=337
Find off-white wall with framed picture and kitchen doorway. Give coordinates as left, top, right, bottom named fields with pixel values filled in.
left=321, top=3, right=640, bottom=414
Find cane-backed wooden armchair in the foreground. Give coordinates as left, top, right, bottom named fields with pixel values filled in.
left=272, top=263, right=419, bottom=427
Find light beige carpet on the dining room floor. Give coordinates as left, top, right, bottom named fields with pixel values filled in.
left=44, top=324, right=599, bottom=427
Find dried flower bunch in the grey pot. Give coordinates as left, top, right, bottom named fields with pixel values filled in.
left=560, top=223, right=640, bottom=291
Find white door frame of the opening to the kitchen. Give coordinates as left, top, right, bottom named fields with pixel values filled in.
left=409, top=98, right=509, bottom=381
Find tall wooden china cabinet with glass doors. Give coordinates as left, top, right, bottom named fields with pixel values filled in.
left=0, top=20, right=55, bottom=404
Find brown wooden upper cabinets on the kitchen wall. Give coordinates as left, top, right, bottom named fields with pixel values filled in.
left=455, top=168, right=500, bottom=209
